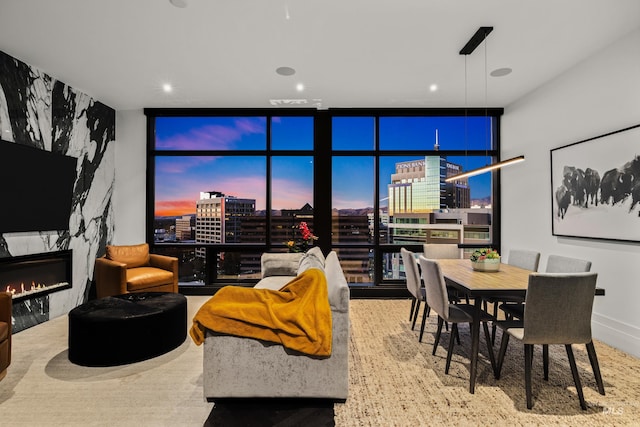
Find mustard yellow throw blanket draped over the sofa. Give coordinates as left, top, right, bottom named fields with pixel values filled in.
left=189, top=268, right=332, bottom=357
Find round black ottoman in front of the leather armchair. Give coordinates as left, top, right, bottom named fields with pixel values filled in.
left=69, top=292, right=187, bottom=366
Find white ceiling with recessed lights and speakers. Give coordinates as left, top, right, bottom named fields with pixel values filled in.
left=0, top=0, right=640, bottom=110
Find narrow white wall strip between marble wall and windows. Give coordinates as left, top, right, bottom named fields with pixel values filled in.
left=112, top=110, right=147, bottom=245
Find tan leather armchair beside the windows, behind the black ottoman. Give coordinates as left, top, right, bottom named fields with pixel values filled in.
left=94, top=243, right=178, bottom=298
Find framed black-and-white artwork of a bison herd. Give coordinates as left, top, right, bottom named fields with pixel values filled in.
left=551, top=124, right=640, bottom=242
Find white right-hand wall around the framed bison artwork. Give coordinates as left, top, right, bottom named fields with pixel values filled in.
left=501, top=30, right=640, bottom=357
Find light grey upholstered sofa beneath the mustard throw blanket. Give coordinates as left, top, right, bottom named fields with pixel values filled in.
left=203, top=248, right=349, bottom=400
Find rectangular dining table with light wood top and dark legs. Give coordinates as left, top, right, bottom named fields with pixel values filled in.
left=437, top=259, right=604, bottom=393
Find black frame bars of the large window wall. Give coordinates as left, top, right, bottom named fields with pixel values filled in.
left=144, top=108, right=504, bottom=297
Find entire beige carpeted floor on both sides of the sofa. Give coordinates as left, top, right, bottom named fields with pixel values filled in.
left=0, top=296, right=640, bottom=427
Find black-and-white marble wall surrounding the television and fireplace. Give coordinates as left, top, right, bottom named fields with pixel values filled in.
left=0, top=51, right=115, bottom=332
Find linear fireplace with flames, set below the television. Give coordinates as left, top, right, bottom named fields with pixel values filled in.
left=0, top=250, right=72, bottom=302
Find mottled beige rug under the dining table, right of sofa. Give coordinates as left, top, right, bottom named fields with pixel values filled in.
left=335, top=300, right=640, bottom=426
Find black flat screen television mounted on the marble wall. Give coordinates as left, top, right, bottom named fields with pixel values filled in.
left=0, top=140, right=77, bottom=233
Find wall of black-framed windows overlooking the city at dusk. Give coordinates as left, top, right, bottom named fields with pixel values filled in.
left=145, top=109, right=502, bottom=293
